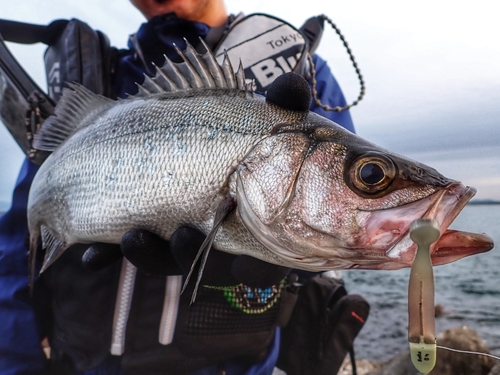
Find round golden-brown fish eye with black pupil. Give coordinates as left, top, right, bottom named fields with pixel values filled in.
left=349, top=153, right=396, bottom=195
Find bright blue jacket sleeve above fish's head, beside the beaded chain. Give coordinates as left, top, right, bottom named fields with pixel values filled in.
left=310, top=55, right=355, bottom=133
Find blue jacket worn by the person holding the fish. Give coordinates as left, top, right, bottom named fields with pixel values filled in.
left=0, top=11, right=354, bottom=375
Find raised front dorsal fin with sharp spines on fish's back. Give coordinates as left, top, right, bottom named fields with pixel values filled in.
left=131, top=38, right=252, bottom=98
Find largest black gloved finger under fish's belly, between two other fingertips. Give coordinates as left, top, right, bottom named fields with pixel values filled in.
left=121, top=229, right=182, bottom=275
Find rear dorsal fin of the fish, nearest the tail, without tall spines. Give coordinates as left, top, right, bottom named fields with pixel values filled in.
left=33, top=83, right=116, bottom=151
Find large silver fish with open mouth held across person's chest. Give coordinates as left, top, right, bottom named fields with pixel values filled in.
left=28, top=41, right=493, bottom=271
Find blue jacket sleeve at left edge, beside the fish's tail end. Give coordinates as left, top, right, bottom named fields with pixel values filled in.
left=0, top=160, right=46, bottom=375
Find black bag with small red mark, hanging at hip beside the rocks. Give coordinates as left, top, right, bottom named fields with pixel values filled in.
left=277, top=275, right=370, bottom=375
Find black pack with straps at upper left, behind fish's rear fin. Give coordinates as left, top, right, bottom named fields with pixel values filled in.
left=0, top=19, right=114, bottom=165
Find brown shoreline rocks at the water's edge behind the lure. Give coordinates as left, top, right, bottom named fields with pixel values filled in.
left=338, top=327, right=500, bottom=375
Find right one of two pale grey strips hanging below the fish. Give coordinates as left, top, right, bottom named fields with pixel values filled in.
left=158, top=275, right=182, bottom=345
